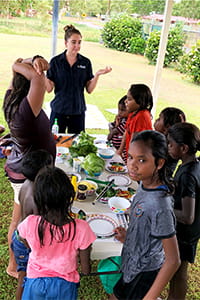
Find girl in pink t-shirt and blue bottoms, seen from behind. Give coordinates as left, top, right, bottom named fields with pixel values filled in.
left=18, top=167, right=96, bottom=300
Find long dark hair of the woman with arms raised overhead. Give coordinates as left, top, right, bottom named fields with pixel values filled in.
left=3, top=72, right=30, bottom=125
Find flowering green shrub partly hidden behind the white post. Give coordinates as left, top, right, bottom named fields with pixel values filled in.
left=145, top=24, right=185, bottom=67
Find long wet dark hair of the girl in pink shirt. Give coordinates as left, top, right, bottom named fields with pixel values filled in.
left=34, top=167, right=76, bottom=246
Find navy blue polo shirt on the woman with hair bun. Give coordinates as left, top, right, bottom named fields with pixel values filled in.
left=47, top=50, right=94, bottom=115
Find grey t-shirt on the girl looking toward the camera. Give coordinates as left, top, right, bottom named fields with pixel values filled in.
left=121, top=186, right=175, bottom=282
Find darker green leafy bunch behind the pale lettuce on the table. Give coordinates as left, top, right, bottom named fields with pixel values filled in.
left=69, top=131, right=97, bottom=158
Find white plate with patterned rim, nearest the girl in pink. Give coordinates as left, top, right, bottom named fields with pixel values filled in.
left=87, top=215, right=118, bottom=238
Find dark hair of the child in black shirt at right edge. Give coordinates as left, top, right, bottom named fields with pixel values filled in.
left=168, top=122, right=200, bottom=154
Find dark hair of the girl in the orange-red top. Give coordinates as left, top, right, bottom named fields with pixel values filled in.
left=129, top=84, right=153, bottom=111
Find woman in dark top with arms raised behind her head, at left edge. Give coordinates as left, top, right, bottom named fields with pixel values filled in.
left=3, top=55, right=56, bottom=277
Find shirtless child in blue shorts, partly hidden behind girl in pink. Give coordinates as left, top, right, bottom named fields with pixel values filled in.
left=11, top=150, right=53, bottom=300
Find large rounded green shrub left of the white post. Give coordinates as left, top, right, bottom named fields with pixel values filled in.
left=102, top=15, right=142, bottom=52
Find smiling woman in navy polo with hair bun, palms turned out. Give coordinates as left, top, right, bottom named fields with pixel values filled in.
left=46, top=25, right=111, bottom=133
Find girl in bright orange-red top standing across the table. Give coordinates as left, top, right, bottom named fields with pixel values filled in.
left=117, top=84, right=153, bottom=162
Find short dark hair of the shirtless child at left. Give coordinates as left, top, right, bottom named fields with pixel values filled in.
left=22, top=149, right=53, bottom=181
